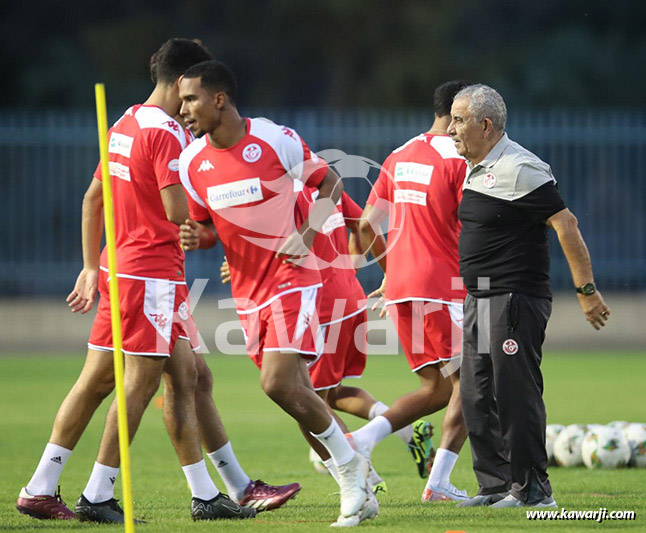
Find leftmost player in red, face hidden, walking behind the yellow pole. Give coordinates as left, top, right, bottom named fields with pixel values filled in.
left=17, top=39, right=292, bottom=522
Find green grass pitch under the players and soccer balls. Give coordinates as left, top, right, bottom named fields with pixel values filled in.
left=0, top=353, right=646, bottom=533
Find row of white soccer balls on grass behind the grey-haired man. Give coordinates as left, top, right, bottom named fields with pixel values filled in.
left=546, top=421, right=646, bottom=468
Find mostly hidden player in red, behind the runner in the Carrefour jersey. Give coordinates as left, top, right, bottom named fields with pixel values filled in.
left=292, top=187, right=430, bottom=490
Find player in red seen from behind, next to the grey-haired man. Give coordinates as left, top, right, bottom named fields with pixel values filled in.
left=352, top=81, right=474, bottom=501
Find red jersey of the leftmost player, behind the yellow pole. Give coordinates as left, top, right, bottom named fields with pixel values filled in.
left=94, top=105, right=187, bottom=281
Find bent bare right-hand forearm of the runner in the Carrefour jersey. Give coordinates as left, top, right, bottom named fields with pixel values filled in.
left=276, top=168, right=343, bottom=261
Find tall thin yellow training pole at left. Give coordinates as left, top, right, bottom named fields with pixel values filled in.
left=94, top=83, right=135, bottom=533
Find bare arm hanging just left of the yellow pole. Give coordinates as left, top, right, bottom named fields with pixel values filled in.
left=67, top=179, right=103, bottom=314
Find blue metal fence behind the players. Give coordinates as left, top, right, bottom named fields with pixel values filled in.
left=0, top=109, right=646, bottom=296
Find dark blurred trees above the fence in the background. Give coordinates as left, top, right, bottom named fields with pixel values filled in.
left=0, top=0, right=646, bottom=109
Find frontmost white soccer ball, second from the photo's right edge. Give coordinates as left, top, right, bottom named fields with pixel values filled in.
left=581, top=426, right=630, bottom=468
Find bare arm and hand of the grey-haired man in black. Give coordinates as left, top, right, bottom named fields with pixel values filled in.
left=547, top=208, right=610, bottom=330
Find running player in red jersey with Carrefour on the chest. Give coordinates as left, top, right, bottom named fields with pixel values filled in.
left=180, top=61, right=378, bottom=522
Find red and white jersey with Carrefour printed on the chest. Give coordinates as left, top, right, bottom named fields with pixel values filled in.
left=180, top=118, right=328, bottom=313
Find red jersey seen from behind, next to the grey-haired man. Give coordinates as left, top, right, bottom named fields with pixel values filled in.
left=367, top=133, right=467, bottom=303
